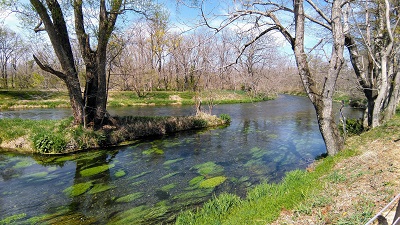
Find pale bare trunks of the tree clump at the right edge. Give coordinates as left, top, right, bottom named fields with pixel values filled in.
left=344, top=0, right=400, bottom=128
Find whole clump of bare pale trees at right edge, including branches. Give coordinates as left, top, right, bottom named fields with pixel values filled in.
left=344, top=0, right=400, bottom=128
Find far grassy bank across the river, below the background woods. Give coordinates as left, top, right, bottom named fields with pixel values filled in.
left=0, top=90, right=270, bottom=110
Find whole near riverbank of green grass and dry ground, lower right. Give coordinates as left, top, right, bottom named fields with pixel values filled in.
left=177, top=114, right=400, bottom=225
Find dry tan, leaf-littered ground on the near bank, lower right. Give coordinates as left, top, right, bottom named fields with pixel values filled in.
left=273, top=124, right=400, bottom=225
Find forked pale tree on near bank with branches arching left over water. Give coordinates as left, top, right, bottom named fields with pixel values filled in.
left=183, top=0, right=345, bottom=155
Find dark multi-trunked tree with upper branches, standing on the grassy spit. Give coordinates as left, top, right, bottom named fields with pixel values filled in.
left=3, top=0, right=159, bottom=127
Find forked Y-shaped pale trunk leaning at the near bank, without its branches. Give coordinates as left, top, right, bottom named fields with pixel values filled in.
left=293, top=0, right=344, bottom=155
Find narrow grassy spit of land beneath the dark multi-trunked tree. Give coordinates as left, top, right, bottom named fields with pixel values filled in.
left=0, top=113, right=230, bottom=154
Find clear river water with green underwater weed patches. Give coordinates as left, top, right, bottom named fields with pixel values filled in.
left=0, top=95, right=361, bottom=224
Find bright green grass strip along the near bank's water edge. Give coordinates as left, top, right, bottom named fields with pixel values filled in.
left=176, top=150, right=356, bottom=224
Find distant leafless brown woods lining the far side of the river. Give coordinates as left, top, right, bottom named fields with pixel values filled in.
left=0, top=13, right=362, bottom=98
